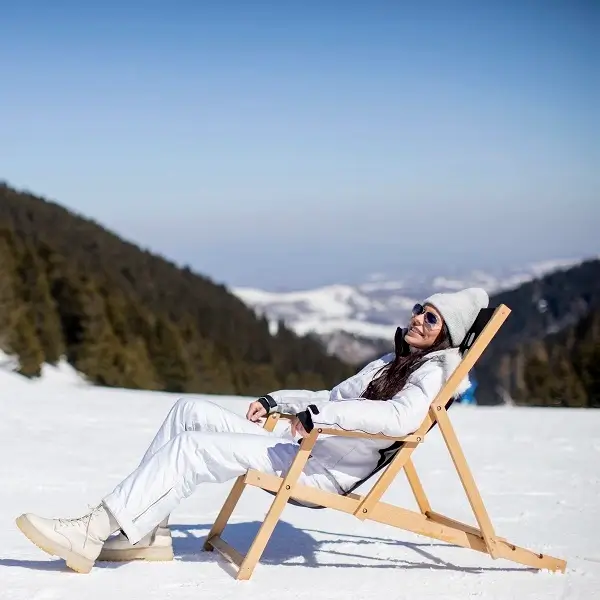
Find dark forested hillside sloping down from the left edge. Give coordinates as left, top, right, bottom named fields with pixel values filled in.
left=0, top=183, right=352, bottom=395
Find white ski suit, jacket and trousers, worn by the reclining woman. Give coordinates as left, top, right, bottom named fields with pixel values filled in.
left=103, top=348, right=469, bottom=544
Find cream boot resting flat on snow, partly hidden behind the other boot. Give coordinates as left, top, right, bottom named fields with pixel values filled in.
left=97, top=521, right=173, bottom=562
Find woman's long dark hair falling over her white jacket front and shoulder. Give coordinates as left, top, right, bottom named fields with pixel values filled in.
left=362, top=323, right=451, bottom=400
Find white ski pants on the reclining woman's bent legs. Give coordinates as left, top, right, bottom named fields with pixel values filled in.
left=103, top=398, right=340, bottom=544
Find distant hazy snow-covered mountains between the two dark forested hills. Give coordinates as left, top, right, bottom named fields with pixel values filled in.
left=232, top=259, right=581, bottom=362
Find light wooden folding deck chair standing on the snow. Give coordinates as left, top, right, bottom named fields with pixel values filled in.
left=204, top=305, right=566, bottom=579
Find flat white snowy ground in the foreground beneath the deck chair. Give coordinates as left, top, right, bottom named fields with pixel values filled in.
left=0, top=365, right=600, bottom=600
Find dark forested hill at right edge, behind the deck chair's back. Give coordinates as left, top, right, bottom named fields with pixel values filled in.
left=477, top=260, right=600, bottom=406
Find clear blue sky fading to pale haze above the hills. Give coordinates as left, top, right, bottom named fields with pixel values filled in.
left=0, top=0, right=600, bottom=288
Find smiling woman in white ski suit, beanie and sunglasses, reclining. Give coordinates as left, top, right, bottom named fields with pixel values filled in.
left=17, top=288, right=488, bottom=573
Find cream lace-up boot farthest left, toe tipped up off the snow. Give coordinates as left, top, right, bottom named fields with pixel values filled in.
left=17, top=504, right=119, bottom=573
